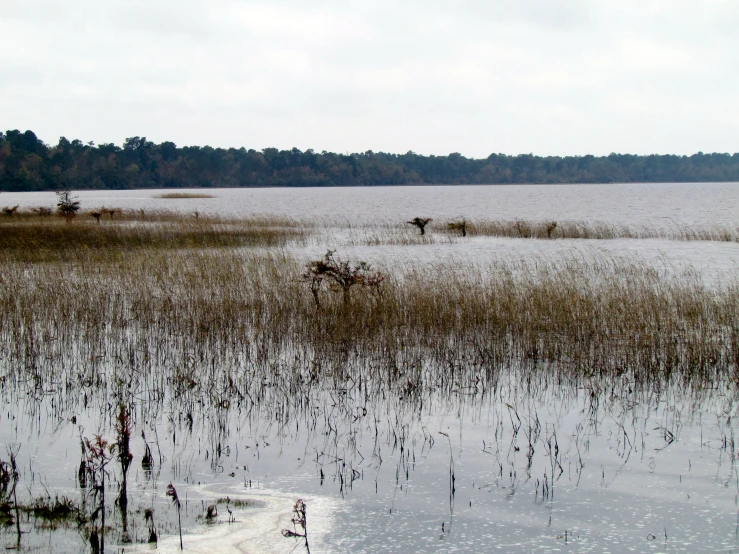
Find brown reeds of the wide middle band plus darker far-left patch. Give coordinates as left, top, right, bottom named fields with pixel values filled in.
left=0, top=212, right=739, bottom=414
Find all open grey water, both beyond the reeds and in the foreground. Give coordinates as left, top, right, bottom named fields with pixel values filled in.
left=0, top=184, right=739, bottom=553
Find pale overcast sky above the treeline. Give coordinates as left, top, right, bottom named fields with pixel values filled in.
left=0, top=0, right=739, bottom=158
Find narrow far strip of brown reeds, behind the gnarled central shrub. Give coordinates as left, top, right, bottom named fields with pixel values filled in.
left=0, top=207, right=739, bottom=261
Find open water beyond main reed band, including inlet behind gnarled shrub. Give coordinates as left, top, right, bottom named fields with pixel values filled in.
left=0, top=183, right=739, bottom=282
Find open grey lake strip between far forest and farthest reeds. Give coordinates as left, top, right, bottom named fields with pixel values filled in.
left=0, top=183, right=739, bottom=225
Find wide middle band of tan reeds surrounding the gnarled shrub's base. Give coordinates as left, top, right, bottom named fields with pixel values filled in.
left=0, top=249, right=739, bottom=396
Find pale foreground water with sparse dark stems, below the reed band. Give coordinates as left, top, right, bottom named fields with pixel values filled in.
left=2, top=360, right=739, bottom=552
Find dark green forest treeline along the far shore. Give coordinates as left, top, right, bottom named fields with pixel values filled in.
left=0, top=130, right=739, bottom=191
